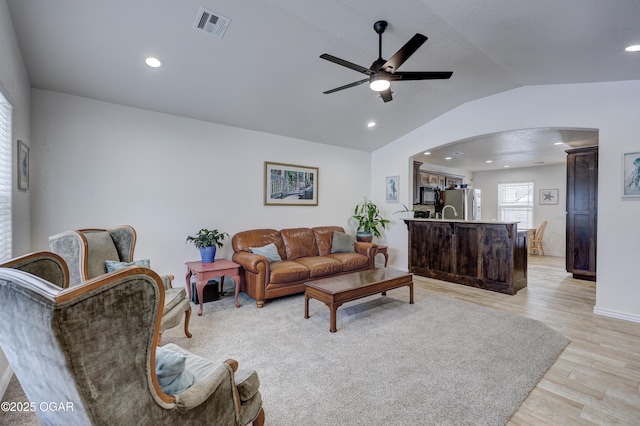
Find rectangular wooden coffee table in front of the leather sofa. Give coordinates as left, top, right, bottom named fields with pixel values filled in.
left=304, top=268, right=413, bottom=333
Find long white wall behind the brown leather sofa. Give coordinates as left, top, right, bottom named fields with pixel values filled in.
left=31, top=89, right=371, bottom=285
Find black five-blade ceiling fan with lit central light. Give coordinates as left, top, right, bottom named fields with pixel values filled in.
left=320, top=21, right=453, bottom=102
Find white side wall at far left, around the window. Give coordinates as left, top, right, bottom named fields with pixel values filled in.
left=0, top=0, right=31, bottom=395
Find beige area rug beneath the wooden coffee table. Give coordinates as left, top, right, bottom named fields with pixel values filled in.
left=0, top=287, right=569, bottom=426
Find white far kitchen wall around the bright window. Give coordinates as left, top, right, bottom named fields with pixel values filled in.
left=473, top=163, right=567, bottom=256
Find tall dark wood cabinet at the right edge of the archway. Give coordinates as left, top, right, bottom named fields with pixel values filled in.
left=566, top=146, right=598, bottom=281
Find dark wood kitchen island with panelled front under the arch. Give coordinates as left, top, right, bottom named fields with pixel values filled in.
left=405, top=219, right=527, bottom=295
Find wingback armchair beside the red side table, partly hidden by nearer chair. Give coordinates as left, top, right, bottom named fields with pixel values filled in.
left=49, top=225, right=191, bottom=337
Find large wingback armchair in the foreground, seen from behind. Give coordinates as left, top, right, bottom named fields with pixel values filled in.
left=0, top=253, right=264, bottom=425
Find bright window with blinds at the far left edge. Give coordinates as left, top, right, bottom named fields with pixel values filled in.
left=0, top=92, right=13, bottom=261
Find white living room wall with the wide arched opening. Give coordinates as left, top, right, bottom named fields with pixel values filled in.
left=372, top=81, right=640, bottom=322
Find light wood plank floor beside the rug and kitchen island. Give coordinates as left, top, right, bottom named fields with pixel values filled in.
left=414, top=256, right=640, bottom=426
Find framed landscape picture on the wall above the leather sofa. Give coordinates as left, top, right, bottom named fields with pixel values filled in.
left=264, top=161, right=318, bottom=206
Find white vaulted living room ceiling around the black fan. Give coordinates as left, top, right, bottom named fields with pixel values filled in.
left=7, top=0, right=640, bottom=160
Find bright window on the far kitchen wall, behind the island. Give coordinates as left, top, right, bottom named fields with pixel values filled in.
left=498, top=182, right=533, bottom=229
